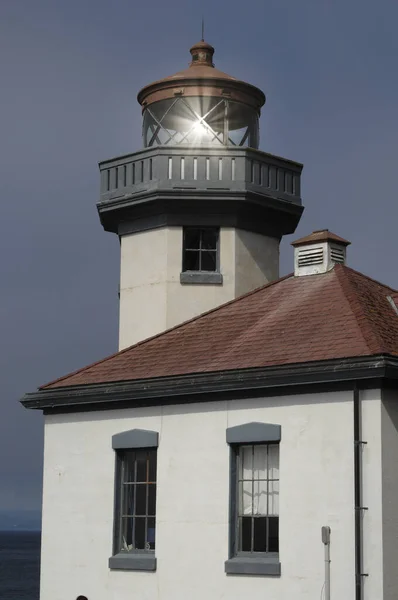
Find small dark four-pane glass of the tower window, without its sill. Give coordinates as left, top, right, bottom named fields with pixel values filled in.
left=182, top=227, right=219, bottom=273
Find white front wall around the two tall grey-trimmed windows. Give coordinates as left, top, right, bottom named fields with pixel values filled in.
left=41, top=392, right=374, bottom=600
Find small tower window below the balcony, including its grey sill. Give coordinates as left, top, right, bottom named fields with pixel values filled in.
left=180, top=226, right=222, bottom=284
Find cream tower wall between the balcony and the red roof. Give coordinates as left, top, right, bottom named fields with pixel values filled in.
left=119, top=227, right=279, bottom=350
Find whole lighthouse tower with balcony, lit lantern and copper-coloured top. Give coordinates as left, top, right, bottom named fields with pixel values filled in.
left=98, top=41, right=303, bottom=349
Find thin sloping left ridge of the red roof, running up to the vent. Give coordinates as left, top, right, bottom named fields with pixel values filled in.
left=38, top=273, right=293, bottom=390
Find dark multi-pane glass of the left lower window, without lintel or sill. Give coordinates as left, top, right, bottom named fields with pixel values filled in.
left=115, top=449, right=156, bottom=552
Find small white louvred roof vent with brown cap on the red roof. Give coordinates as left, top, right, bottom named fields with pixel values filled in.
left=292, top=229, right=350, bottom=277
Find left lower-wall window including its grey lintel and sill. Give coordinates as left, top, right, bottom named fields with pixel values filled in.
left=109, top=429, right=158, bottom=571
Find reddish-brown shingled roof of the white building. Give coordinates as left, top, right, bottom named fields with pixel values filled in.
left=40, top=265, right=398, bottom=389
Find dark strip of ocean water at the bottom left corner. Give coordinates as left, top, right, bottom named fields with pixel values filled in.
left=0, top=531, right=40, bottom=600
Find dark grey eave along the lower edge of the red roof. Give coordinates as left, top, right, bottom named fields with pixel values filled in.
left=21, top=355, right=398, bottom=413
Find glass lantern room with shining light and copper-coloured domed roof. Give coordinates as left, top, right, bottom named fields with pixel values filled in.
left=138, top=40, right=265, bottom=149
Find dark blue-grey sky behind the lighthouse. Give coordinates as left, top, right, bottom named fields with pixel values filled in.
left=0, top=0, right=398, bottom=510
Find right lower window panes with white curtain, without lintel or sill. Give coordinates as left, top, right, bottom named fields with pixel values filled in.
left=235, top=444, right=279, bottom=554
